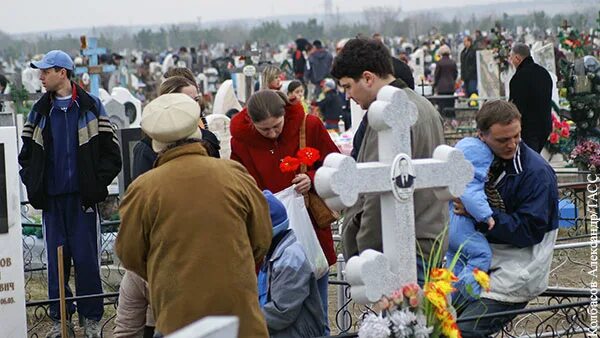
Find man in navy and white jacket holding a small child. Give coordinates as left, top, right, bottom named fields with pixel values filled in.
left=454, top=100, right=558, bottom=338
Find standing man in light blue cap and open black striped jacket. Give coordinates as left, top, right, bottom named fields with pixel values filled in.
left=19, top=50, right=121, bottom=338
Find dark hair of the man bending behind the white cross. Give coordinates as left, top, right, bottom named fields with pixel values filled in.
left=331, top=38, right=394, bottom=81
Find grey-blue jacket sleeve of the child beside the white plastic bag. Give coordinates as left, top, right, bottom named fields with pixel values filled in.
left=262, top=250, right=312, bottom=331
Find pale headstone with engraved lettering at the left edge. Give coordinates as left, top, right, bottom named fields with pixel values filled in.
left=0, top=127, right=27, bottom=337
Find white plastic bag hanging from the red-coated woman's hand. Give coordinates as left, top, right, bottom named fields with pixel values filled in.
left=275, top=186, right=329, bottom=279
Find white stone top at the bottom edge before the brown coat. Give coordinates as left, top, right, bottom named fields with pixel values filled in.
left=166, top=316, right=240, bottom=338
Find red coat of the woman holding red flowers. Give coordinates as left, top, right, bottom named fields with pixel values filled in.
left=231, top=104, right=339, bottom=265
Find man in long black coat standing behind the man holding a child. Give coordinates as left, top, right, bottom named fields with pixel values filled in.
left=509, top=43, right=552, bottom=153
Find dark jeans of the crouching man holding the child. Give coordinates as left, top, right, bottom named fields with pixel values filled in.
left=454, top=295, right=527, bottom=338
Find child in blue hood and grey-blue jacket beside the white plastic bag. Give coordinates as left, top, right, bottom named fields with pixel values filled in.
left=258, top=190, right=326, bottom=337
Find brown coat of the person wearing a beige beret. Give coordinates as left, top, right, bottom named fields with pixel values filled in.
left=115, top=143, right=272, bottom=337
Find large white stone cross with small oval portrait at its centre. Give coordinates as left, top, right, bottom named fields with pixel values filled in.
left=315, top=86, right=473, bottom=304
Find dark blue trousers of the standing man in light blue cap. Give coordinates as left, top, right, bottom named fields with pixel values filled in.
left=42, top=194, right=104, bottom=321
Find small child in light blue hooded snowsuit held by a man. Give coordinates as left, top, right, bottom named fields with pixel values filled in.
left=446, top=137, right=495, bottom=300
